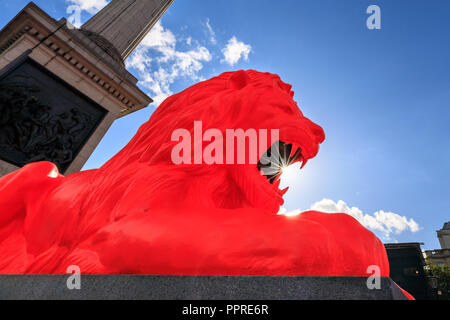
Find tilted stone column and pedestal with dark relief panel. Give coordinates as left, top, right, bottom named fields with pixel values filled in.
left=0, top=0, right=174, bottom=176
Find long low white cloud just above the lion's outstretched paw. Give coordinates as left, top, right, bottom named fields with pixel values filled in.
left=310, top=199, right=420, bottom=240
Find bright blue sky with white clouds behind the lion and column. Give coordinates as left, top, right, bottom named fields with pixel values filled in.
left=0, top=0, right=450, bottom=249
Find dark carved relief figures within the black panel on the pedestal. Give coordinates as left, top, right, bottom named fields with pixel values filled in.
left=0, top=84, right=92, bottom=171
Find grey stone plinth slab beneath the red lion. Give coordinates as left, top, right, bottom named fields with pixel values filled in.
left=0, top=275, right=406, bottom=300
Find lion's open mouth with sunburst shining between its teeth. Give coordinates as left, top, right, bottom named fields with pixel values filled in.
left=256, top=141, right=302, bottom=183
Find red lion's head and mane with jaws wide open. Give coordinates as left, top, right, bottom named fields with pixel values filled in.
left=99, top=70, right=325, bottom=215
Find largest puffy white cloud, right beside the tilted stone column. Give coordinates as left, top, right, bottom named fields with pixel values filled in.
left=127, top=21, right=212, bottom=105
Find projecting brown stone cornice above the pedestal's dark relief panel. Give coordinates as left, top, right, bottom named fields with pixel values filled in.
left=0, top=2, right=152, bottom=117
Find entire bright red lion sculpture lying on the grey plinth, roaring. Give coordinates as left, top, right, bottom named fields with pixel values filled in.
left=0, top=70, right=389, bottom=277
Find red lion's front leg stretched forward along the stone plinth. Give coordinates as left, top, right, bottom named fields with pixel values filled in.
left=86, top=209, right=389, bottom=276
